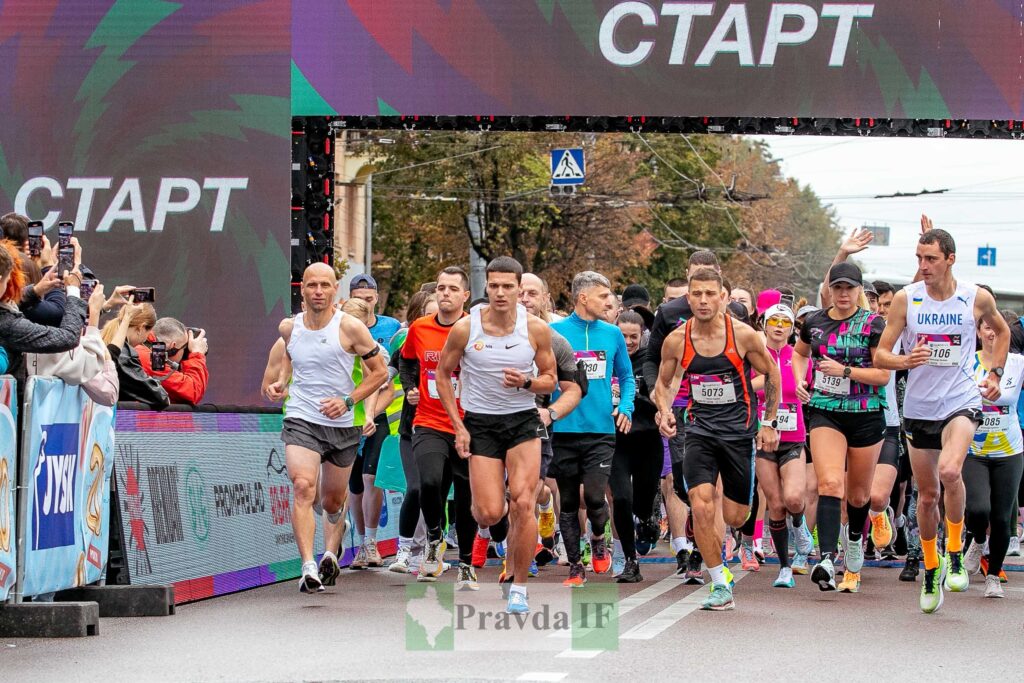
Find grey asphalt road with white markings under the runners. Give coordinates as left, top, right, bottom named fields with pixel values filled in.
left=0, top=562, right=1024, bottom=683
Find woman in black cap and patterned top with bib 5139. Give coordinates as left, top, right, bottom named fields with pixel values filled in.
left=793, top=262, right=889, bottom=593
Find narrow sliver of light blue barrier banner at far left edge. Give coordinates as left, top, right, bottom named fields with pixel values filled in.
left=0, top=376, right=17, bottom=602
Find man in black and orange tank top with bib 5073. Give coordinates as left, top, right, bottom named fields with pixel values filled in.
left=655, top=268, right=781, bottom=610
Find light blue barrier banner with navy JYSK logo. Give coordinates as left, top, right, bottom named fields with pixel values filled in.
left=18, top=377, right=114, bottom=596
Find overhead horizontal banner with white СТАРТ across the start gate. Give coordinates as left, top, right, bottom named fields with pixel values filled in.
left=292, top=0, right=1024, bottom=120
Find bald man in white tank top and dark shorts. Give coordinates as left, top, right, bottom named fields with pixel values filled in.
left=266, top=263, right=388, bottom=593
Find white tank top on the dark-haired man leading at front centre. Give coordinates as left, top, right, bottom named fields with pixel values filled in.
left=460, top=304, right=537, bottom=415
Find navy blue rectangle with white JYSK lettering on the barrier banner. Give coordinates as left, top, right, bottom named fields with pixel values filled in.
left=32, top=423, right=79, bottom=550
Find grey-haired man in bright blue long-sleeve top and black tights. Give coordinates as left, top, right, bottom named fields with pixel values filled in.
left=548, top=270, right=636, bottom=587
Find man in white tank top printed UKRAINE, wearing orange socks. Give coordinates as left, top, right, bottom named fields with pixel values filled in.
left=876, top=227, right=1010, bottom=613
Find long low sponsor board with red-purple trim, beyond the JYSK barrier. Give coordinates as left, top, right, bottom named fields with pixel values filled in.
left=114, top=403, right=403, bottom=603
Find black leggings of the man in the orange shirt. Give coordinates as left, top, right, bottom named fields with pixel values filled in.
left=413, top=427, right=476, bottom=564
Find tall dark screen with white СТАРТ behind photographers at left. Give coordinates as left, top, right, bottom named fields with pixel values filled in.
left=0, top=0, right=291, bottom=404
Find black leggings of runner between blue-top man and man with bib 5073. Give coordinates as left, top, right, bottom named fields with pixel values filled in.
left=608, top=431, right=665, bottom=559
